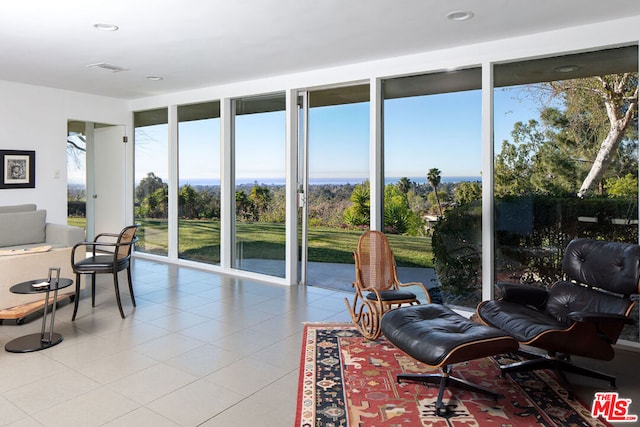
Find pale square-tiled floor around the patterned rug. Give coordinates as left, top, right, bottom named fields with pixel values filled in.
left=0, top=259, right=640, bottom=427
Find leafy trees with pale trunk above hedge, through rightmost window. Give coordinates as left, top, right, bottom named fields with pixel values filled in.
left=495, top=73, right=638, bottom=197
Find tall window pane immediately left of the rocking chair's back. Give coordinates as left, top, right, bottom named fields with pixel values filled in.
left=303, top=84, right=370, bottom=290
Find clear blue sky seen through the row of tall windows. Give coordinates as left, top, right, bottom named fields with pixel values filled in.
left=70, top=88, right=539, bottom=183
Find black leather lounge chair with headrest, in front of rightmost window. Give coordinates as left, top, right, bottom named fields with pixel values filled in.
left=476, top=238, right=640, bottom=393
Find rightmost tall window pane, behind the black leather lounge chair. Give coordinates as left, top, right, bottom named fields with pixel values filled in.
left=494, top=46, right=638, bottom=341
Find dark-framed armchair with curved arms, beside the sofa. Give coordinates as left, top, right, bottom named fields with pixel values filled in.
left=71, top=225, right=138, bottom=321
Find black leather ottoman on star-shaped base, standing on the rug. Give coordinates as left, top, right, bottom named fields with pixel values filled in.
left=381, top=304, right=518, bottom=415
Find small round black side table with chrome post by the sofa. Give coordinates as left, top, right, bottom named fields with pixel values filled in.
left=4, top=268, right=73, bottom=353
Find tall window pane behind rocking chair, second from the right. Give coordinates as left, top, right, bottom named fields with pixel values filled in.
left=383, top=68, right=482, bottom=308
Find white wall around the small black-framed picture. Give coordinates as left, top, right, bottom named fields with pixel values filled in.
left=0, top=81, right=130, bottom=224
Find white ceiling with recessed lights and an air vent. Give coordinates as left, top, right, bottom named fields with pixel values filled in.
left=0, top=0, right=640, bottom=98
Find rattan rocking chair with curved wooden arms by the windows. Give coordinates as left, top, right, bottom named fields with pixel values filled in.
left=345, top=230, right=431, bottom=340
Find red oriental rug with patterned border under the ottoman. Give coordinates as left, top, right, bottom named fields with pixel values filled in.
left=295, top=323, right=609, bottom=427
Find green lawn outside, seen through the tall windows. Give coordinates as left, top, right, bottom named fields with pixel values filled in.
left=69, top=218, right=433, bottom=267
